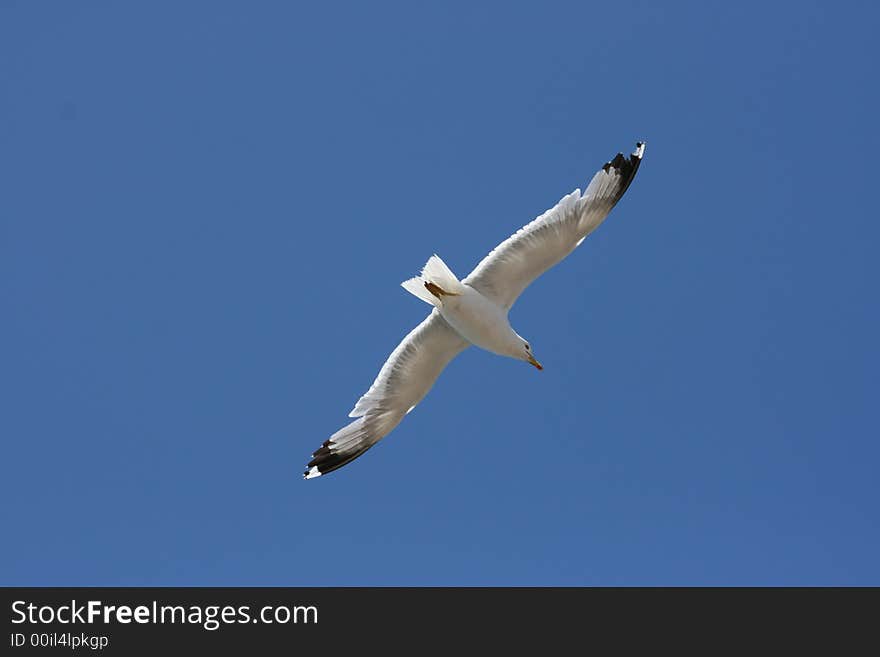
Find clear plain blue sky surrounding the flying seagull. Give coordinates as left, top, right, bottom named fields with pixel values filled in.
left=0, top=2, right=880, bottom=585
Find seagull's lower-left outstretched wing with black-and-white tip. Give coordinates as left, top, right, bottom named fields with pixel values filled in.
left=305, top=309, right=470, bottom=479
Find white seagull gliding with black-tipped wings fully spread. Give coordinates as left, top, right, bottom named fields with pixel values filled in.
left=304, top=142, right=645, bottom=479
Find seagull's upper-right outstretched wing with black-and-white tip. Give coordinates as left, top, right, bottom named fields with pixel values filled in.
left=462, top=142, right=645, bottom=309
